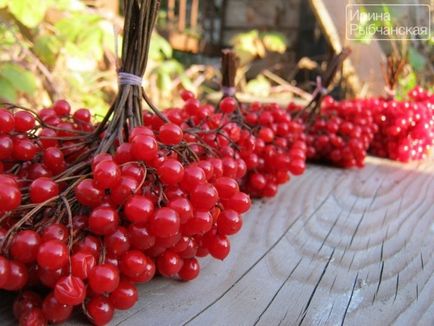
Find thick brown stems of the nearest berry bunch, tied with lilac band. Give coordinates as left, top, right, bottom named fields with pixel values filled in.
left=97, top=0, right=167, bottom=153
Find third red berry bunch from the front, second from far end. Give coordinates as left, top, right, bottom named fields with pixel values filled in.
left=289, top=96, right=377, bottom=168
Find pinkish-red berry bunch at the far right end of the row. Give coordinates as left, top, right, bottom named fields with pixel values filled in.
left=365, top=87, right=434, bottom=162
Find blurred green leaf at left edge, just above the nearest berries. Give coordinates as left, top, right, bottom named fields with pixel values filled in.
left=0, top=63, right=36, bottom=95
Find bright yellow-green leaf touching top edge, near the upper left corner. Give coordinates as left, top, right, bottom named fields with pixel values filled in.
left=8, top=0, right=49, bottom=28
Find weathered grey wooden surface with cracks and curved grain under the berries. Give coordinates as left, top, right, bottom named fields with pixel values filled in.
left=2, top=158, right=434, bottom=326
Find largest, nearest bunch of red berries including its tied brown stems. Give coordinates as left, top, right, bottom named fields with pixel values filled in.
left=0, top=0, right=251, bottom=325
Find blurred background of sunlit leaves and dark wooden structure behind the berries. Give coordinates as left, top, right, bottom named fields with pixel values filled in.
left=0, top=0, right=434, bottom=114
